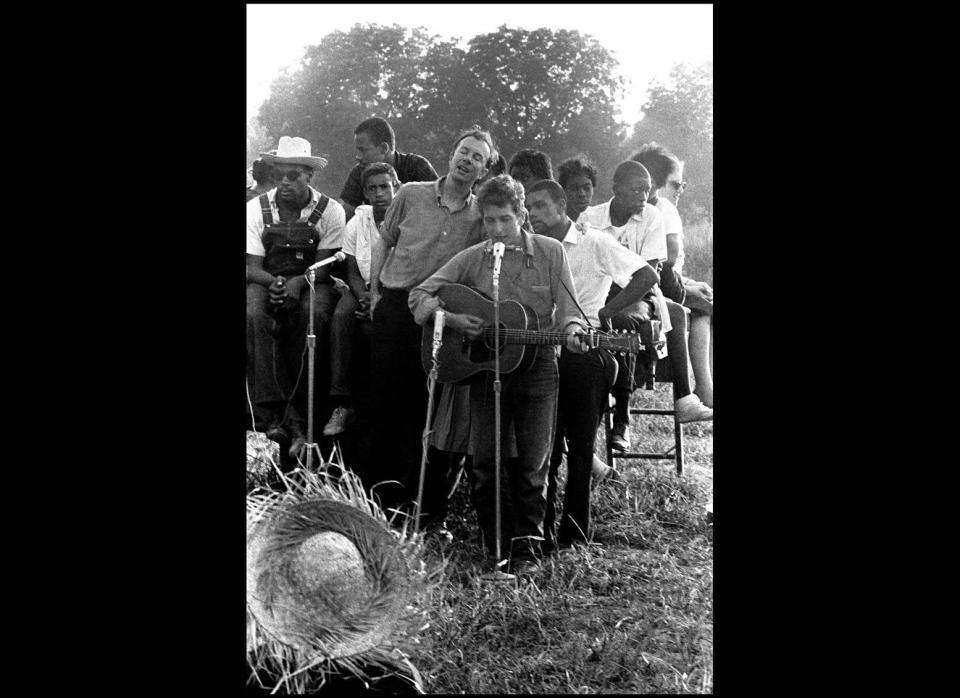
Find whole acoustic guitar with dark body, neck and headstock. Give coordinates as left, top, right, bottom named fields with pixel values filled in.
left=420, top=284, right=645, bottom=383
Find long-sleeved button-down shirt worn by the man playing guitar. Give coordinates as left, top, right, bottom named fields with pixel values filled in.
left=407, top=231, right=583, bottom=332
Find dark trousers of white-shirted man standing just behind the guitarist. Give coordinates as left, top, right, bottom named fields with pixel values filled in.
left=544, top=347, right=618, bottom=545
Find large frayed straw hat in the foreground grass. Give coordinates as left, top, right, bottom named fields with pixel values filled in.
left=247, top=462, right=423, bottom=693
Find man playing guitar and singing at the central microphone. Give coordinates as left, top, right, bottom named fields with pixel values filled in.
left=409, top=175, right=587, bottom=572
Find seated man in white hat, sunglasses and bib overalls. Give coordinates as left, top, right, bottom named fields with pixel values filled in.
left=247, top=136, right=345, bottom=457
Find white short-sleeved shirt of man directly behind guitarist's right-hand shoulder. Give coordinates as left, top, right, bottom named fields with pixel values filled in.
left=563, top=221, right=647, bottom=327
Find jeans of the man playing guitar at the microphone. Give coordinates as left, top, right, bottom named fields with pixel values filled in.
left=470, top=347, right=559, bottom=556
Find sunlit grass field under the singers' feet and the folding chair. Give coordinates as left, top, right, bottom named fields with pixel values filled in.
left=410, top=384, right=713, bottom=693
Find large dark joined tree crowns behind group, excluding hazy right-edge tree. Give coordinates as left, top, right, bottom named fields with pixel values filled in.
left=259, top=24, right=624, bottom=196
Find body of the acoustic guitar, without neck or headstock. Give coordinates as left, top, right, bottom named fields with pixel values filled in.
left=420, top=284, right=540, bottom=383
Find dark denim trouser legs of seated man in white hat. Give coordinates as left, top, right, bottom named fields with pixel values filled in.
left=247, top=283, right=334, bottom=427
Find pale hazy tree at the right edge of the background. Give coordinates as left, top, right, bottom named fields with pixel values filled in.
left=623, top=62, right=713, bottom=221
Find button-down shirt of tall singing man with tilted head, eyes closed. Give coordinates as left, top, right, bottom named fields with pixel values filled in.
left=380, top=177, right=484, bottom=291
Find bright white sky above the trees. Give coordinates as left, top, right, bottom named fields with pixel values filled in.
left=247, top=3, right=713, bottom=125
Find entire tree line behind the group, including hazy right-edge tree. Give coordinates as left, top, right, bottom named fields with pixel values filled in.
left=247, top=24, right=713, bottom=221
